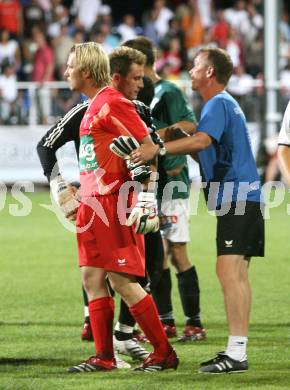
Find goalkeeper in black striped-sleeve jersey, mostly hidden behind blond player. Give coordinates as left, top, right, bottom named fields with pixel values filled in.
left=37, top=49, right=164, bottom=360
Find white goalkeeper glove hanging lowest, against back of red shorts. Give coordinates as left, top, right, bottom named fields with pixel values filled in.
left=126, top=192, right=159, bottom=234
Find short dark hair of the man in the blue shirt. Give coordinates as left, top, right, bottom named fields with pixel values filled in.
left=196, top=48, right=234, bottom=85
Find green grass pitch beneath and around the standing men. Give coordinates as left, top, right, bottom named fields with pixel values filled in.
left=0, top=188, right=290, bottom=390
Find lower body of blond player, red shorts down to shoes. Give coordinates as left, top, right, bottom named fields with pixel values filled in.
left=69, top=193, right=179, bottom=372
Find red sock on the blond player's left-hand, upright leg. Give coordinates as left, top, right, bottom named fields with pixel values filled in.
left=89, top=297, right=114, bottom=360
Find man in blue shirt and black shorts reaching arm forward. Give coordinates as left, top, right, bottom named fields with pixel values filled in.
left=132, top=48, right=264, bottom=374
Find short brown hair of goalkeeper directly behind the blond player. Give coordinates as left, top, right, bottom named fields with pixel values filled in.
left=109, top=46, right=146, bottom=76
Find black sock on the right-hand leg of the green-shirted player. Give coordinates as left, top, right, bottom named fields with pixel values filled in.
left=176, top=266, right=202, bottom=327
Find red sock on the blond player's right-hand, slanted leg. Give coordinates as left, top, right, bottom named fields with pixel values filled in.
left=129, top=294, right=171, bottom=356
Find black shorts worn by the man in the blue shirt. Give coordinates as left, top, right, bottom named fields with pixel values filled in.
left=216, top=201, right=265, bottom=257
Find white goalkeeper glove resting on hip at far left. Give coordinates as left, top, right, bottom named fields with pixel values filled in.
left=50, top=175, right=80, bottom=221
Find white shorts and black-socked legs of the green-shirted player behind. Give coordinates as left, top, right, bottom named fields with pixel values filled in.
left=152, top=199, right=206, bottom=342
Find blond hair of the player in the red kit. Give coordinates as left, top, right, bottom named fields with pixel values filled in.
left=70, top=42, right=111, bottom=87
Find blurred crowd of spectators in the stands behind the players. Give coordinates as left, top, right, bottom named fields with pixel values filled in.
left=0, top=0, right=290, bottom=181
